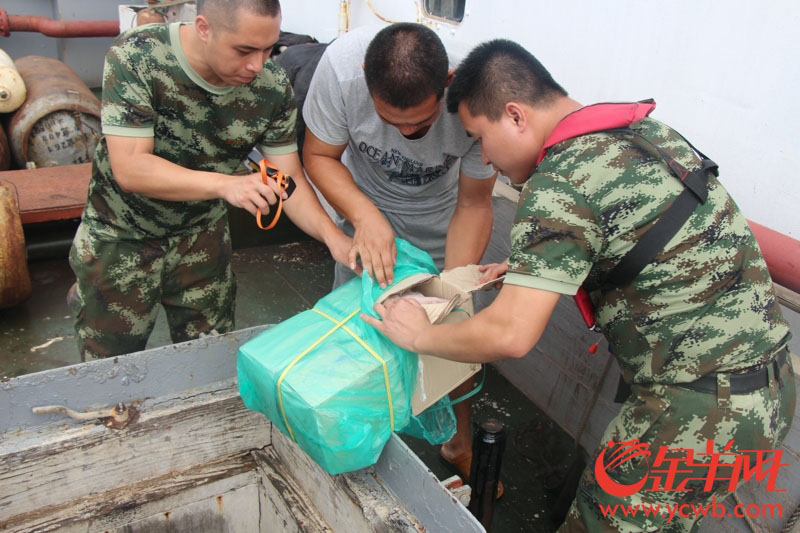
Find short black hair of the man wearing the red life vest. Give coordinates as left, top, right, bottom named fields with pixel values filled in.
left=447, top=39, right=567, bottom=121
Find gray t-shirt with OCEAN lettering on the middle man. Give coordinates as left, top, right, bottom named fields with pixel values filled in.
left=303, top=27, right=494, bottom=219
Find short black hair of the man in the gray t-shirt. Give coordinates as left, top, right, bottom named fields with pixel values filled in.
left=364, top=22, right=450, bottom=109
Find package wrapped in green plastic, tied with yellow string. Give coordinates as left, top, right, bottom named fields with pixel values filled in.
left=237, top=239, right=455, bottom=474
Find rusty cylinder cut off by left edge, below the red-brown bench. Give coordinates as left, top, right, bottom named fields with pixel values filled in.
left=0, top=181, right=31, bottom=309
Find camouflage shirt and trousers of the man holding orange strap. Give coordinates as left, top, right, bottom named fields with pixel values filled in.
left=70, top=24, right=297, bottom=357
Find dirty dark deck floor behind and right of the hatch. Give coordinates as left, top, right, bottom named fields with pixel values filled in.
left=0, top=241, right=574, bottom=533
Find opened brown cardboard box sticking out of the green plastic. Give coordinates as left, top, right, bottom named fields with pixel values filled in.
left=378, top=265, right=497, bottom=415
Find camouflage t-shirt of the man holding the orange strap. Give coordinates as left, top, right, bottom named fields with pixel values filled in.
left=83, top=24, right=297, bottom=239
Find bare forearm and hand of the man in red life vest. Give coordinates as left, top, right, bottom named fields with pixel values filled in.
left=361, top=285, right=560, bottom=363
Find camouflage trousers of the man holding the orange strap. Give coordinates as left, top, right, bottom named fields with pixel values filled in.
left=69, top=217, right=236, bottom=358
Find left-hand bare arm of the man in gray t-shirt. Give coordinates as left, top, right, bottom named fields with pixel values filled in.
left=303, top=128, right=397, bottom=287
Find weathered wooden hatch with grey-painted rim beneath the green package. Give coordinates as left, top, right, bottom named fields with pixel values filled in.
left=0, top=327, right=483, bottom=533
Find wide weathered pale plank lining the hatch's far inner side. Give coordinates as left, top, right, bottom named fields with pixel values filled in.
left=0, top=382, right=270, bottom=526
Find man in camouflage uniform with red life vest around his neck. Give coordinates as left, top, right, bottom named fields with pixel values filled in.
left=365, top=40, right=795, bottom=531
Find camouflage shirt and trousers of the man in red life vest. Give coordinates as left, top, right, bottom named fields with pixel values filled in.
left=505, top=112, right=795, bottom=532
